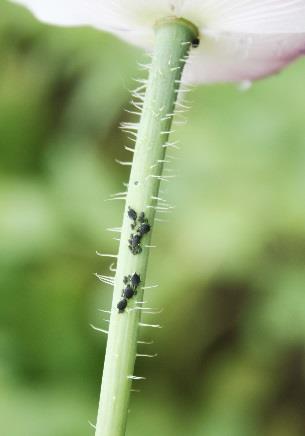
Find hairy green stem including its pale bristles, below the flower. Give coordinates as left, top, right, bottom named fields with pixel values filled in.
left=93, top=18, right=198, bottom=436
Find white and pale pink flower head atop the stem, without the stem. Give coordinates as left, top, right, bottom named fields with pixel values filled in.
left=13, top=0, right=305, bottom=83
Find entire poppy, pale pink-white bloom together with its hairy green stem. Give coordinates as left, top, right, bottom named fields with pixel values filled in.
left=8, top=0, right=305, bottom=436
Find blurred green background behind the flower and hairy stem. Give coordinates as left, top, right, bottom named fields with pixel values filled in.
left=0, top=1, right=305, bottom=436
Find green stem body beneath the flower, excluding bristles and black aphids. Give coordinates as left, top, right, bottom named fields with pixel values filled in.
left=95, top=19, right=198, bottom=436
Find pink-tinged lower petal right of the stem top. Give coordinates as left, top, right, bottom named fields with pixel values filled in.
left=184, top=33, right=305, bottom=83
